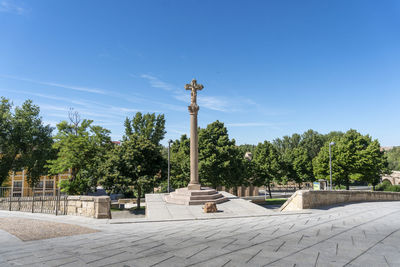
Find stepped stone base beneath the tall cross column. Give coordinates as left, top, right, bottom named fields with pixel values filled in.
left=165, top=185, right=228, bottom=205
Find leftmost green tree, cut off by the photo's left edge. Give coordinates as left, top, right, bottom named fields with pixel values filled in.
left=0, top=97, right=54, bottom=186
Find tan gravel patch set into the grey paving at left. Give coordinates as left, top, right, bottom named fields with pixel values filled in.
left=0, top=218, right=98, bottom=241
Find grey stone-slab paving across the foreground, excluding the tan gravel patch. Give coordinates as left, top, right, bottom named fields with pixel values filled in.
left=0, top=202, right=400, bottom=267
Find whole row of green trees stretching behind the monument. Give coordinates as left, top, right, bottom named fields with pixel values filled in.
left=0, top=97, right=394, bottom=202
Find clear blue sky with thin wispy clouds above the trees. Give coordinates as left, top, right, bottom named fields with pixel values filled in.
left=0, top=0, right=400, bottom=146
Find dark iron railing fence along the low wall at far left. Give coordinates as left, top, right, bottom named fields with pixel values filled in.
left=0, top=187, right=68, bottom=215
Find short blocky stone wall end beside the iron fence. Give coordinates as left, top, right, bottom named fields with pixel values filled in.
left=66, top=196, right=111, bottom=219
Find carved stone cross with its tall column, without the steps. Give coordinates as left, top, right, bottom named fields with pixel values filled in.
left=185, top=79, right=204, bottom=190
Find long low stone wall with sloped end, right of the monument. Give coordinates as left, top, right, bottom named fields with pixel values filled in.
left=280, top=190, right=400, bottom=211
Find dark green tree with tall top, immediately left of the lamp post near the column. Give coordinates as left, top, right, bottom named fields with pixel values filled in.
left=102, top=112, right=167, bottom=209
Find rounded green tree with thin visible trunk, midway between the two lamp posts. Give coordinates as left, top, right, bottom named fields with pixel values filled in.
left=253, top=141, right=284, bottom=198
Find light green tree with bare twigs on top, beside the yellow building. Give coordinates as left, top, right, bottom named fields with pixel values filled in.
left=48, top=112, right=112, bottom=194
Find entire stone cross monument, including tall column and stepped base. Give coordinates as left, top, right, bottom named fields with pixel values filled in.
left=165, top=79, right=228, bottom=205
